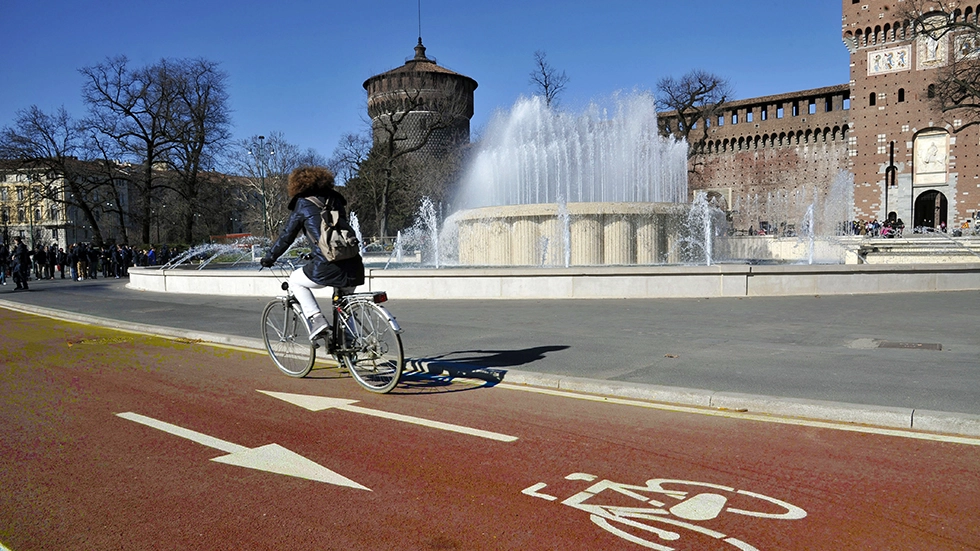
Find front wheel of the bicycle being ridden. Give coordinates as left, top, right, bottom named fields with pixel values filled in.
left=262, top=299, right=316, bottom=377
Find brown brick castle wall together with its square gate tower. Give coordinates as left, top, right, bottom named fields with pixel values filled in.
left=661, top=0, right=980, bottom=233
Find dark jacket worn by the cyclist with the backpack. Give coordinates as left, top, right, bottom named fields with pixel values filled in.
left=269, top=190, right=364, bottom=287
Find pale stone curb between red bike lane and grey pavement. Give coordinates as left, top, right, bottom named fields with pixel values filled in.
left=7, top=300, right=980, bottom=437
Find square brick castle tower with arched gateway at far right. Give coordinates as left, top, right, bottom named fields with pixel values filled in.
left=842, top=0, right=980, bottom=228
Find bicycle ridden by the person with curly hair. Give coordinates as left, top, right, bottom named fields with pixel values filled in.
left=262, top=266, right=405, bottom=394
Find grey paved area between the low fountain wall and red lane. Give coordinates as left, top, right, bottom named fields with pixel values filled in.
left=0, top=279, right=980, bottom=435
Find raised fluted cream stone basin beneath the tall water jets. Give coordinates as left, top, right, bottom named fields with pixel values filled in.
left=453, top=203, right=691, bottom=266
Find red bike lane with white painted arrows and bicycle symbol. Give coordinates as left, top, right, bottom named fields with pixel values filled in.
left=0, top=310, right=980, bottom=551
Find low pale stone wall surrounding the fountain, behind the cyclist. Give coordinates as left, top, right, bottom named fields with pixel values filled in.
left=128, top=263, right=980, bottom=299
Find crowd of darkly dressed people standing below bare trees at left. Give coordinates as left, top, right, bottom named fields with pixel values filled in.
left=0, top=237, right=177, bottom=290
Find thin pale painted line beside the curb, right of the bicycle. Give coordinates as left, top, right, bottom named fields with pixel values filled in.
left=494, top=383, right=980, bottom=446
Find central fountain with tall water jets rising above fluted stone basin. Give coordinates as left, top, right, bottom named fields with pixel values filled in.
left=444, top=93, right=687, bottom=267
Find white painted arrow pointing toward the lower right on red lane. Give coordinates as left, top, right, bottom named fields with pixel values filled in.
left=116, top=412, right=371, bottom=492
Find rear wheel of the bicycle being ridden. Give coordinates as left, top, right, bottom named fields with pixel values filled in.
left=338, top=302, right=405, bottom=393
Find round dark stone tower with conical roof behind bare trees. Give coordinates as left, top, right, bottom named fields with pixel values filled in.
left=364, top=38, right=477, bottom=160
